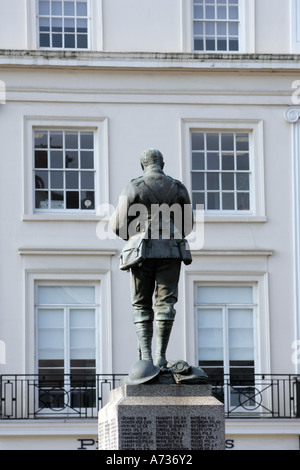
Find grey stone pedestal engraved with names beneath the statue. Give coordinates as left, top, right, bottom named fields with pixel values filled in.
left=98, top=384, right=225, bottom=450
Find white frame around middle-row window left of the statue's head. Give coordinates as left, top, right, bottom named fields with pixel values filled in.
left=23, top=116, right=109, bottom=220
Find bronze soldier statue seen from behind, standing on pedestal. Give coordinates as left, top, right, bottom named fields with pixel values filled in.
left=111, top=149, right=193, bottom=368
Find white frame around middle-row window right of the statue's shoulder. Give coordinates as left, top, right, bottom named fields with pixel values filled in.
left=181, top=118, right=266, bottom=222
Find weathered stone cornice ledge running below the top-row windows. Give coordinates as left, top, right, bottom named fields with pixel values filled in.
left=0, top=50, right=300, bottom=72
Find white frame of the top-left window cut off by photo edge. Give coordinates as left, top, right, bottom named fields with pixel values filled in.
left=26, top=0, right=103, bottom=53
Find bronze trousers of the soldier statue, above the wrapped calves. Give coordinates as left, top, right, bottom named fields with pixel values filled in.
left=131, top=258, right=181, bottom=323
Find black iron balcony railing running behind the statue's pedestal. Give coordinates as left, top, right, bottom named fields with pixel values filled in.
left=0, top=374, right=300, bottom=420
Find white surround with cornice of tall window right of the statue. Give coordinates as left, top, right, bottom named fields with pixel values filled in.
left=183, top=270, right=271, bottom=374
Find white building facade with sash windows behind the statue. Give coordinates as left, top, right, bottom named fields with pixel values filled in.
left=0, top=0, right=300, bottom=450
